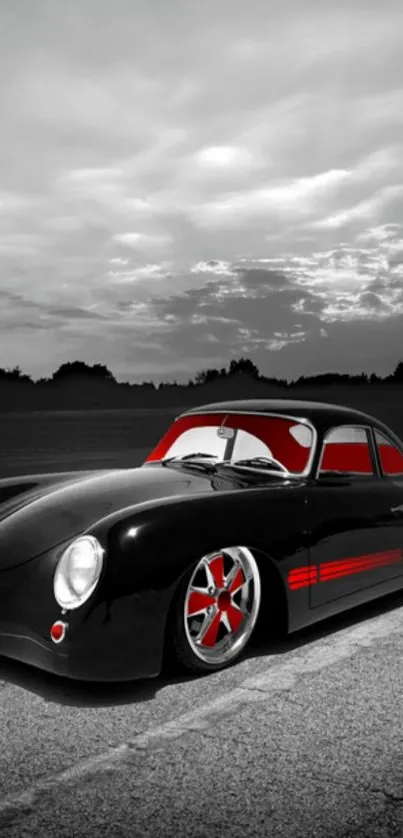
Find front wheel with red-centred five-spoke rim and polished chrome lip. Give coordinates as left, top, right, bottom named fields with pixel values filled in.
left=171, top=547, right=261, bottom=672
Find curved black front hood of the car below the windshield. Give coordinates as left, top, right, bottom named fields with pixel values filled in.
left=0, top=465, right=304, bottom=570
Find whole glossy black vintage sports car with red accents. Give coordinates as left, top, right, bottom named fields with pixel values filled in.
left=0, top=400, right=403, bottom=681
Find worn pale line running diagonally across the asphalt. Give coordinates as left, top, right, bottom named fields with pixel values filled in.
left=0, top=608, right=403, bottom=826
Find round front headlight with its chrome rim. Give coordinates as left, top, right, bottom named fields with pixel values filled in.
left=53, top=535, right=104, bottom=610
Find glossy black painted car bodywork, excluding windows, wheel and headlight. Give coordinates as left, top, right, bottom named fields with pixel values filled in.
left=0, top=401, right=403, bottom=680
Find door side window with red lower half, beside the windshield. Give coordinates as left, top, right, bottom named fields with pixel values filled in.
left=319, top=425, right=374, bottom=474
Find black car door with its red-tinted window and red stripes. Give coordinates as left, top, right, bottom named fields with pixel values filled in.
left=307, top=425, right=403, bottom=608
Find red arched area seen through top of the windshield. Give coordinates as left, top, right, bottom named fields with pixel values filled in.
left=145, top=413, right=311, bottom=474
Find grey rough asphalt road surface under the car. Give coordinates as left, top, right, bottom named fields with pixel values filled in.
left=0, top=593, right=403, bottom=838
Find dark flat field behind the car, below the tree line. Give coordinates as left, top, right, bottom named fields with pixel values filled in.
left=0, top=387, right=403, bottom=477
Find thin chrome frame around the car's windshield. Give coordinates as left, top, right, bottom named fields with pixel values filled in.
left=146, top=409, right=319, bottom=479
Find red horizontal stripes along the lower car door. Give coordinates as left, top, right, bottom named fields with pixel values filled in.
left=287, top=548, right=403, bottom=591
